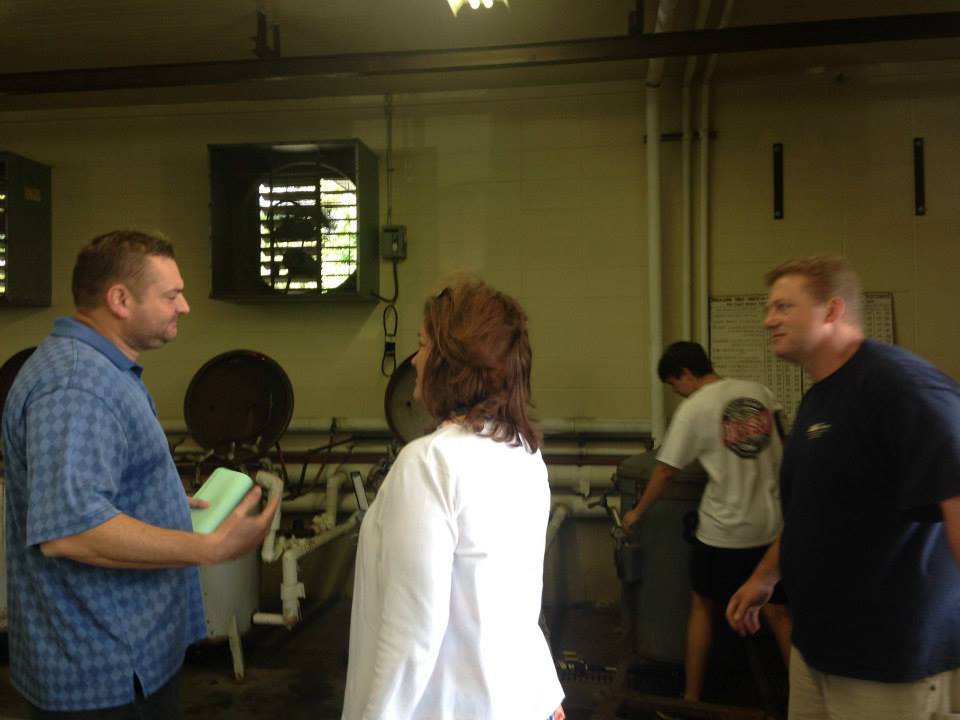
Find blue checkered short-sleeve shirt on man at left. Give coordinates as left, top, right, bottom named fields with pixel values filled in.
left=3, top=318, right=206, bottom=710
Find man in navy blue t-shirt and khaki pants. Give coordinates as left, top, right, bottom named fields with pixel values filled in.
left=727, top=257, right=960, bottom=720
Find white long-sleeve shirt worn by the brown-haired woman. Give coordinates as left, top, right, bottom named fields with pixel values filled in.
left=343, top=424, right=563, bottom=720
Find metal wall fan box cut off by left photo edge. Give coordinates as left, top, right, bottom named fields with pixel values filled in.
left=0, top=152, right=53, bottom=307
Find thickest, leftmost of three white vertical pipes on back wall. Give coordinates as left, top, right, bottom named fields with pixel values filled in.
left=644, top=0, right=677, bottom=445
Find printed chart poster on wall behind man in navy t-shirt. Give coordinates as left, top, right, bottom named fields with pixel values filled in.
left=710, top=292, right=896, bottom=428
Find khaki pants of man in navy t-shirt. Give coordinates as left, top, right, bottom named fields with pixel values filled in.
left=789, top=648, right=960, bottom=720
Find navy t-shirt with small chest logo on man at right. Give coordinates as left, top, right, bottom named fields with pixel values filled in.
left=781, top=340, right=960, bottom=682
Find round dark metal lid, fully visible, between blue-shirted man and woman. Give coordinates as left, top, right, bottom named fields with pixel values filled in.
left=183, top=350, right=293, bottom=460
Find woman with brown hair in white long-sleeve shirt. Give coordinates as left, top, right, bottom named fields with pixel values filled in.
left=343, top=281, right=563, bottom=720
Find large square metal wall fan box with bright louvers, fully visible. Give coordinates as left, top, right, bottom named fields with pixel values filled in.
left=209, top=139, right=380, bottom=302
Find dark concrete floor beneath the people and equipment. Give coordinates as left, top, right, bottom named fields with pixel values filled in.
left=0, top=599, right=785, bottom=720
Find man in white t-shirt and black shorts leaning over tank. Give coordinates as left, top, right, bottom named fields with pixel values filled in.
left=623, top=342, right=791, bottom=700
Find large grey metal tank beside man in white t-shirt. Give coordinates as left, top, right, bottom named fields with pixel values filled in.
left=614, top=452, right=707, bottom=664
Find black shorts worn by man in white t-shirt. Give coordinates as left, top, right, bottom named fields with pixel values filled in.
left=690, top=538, right=787, bottom=608
